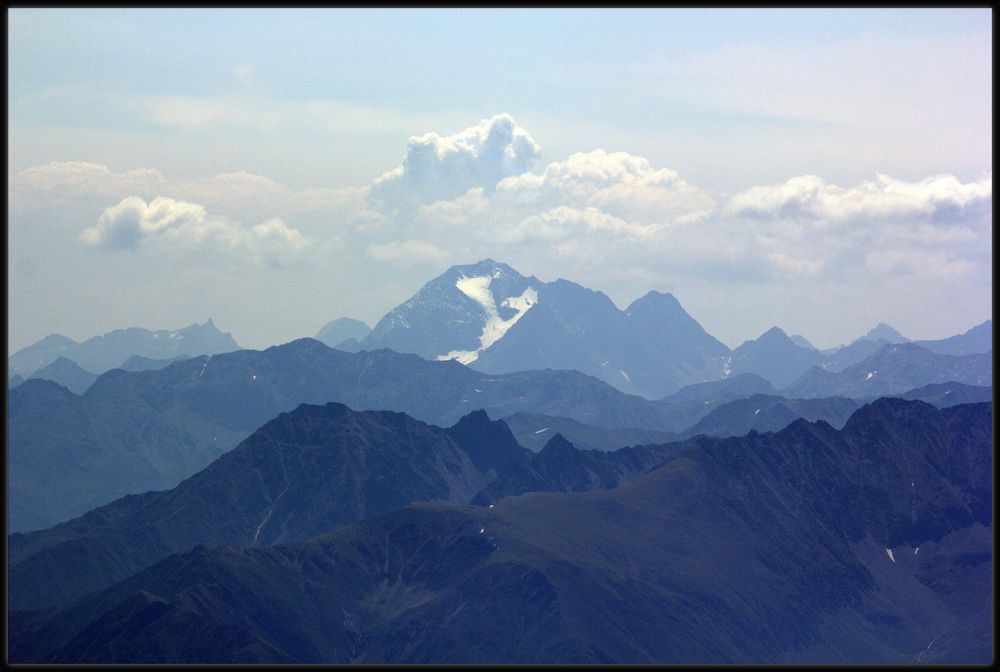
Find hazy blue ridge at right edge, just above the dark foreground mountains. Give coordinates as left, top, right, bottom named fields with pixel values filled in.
left=781, top=343, right=993, bottom=399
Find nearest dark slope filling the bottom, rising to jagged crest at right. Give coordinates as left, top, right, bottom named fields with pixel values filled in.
left=10, top=399, right=992, bottom=664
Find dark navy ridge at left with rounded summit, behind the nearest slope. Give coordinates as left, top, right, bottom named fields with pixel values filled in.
left=9, top=403, right=529, bottom=608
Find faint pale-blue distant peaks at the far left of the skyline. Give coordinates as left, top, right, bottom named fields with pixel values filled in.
left=7, top=319, right=239, bottom=377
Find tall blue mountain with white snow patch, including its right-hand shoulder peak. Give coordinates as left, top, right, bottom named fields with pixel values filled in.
left=358, top=259, right=729, bottom=398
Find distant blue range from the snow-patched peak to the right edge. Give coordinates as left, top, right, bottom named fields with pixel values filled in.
left=321, top=259, right=992, bottom=399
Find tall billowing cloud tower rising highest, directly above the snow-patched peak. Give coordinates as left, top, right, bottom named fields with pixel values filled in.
left=369, top=114, right=541, bottom=214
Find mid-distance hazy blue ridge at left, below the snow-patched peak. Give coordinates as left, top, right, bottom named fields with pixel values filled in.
left=8, top=339, right=671, bottom=532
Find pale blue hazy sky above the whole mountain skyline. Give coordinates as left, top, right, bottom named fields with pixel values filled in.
left=8, top=9, right=992, bottom=349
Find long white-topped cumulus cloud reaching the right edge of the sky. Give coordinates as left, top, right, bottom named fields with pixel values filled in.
left=721, top=174, right=993, bottom=279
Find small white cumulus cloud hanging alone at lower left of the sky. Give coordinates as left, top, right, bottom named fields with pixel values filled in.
left=79, top=196, right=311, bottom=265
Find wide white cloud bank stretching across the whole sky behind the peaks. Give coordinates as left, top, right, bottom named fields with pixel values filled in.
left=8, top=114, right=992, bottom=342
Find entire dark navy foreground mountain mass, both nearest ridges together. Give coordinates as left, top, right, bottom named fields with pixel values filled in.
left=10, top=399, right=992, bottom=664
